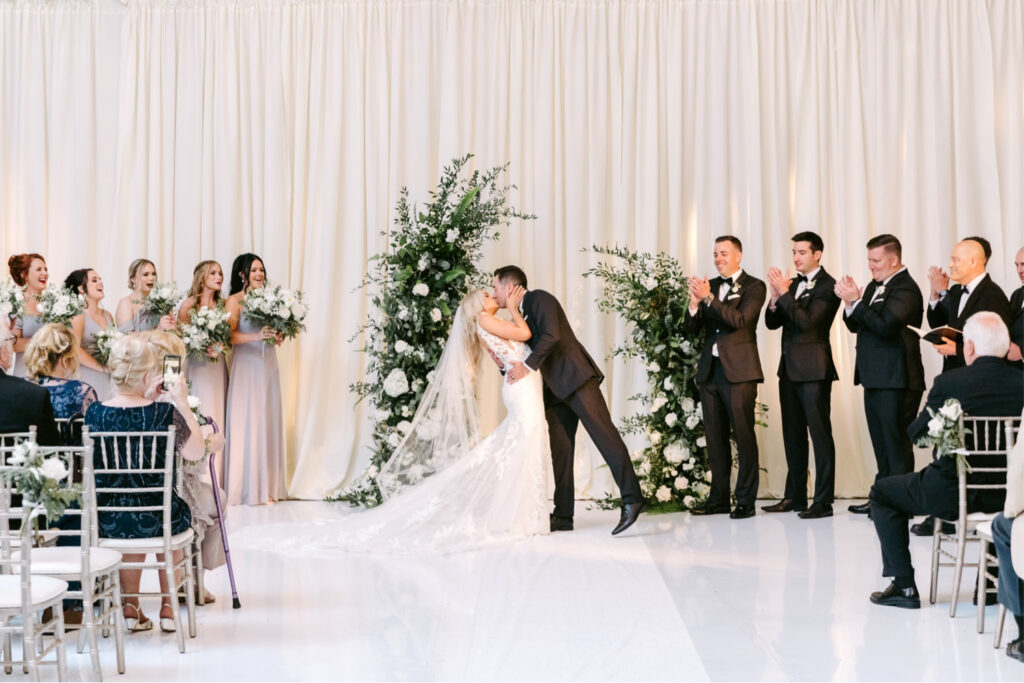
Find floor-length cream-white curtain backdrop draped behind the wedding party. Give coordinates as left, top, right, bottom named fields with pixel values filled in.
left=0, top=0, right=1024, bottom=498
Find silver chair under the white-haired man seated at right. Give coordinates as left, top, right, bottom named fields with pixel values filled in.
left=928, top=415, right=1020, bottom=616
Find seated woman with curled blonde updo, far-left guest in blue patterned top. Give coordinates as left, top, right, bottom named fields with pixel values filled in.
left=25, top=323, right=96, bottom=420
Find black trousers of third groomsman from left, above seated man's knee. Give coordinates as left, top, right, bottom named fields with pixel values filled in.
left=864, top=388, right=924, bottom=481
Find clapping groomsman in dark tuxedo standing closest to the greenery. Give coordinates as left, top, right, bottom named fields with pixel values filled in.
left=683, top=234, right=767, bottom=519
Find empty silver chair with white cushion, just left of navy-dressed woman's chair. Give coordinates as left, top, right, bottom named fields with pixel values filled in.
left=32, top=436, right=125, bottom=681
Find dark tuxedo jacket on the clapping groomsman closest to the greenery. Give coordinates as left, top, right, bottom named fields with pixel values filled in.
left=683, top=270, right=768, bottom=384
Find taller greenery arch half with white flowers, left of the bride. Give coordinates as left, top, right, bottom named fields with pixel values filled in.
left=328, top=155, right=535, bottom=507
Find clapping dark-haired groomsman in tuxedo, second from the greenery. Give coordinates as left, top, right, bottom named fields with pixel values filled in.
left=762, top=232, right=840, bottom=519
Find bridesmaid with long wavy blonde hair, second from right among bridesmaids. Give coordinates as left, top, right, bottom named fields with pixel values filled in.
left=178, top=261, right=227, bottom=484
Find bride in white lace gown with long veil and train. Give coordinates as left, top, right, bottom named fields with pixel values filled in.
left=240, top=288, right=551, bottom=555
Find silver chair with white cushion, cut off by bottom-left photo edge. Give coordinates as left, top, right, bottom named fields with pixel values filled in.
left=0, top=446, right=68, bottom=681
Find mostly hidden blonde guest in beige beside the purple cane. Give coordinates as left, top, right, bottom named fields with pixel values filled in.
left=141, top=331, right=226, bottom=602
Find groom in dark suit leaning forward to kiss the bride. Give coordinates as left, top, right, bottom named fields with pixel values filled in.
left=494, top=265, right=647, bottom=536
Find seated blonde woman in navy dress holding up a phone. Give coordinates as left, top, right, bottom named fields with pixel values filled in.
left=85, top=336, right=204, bottom=631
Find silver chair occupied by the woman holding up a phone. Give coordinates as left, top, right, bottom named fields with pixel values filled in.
left=89, top=426, right=196, bottom=652
